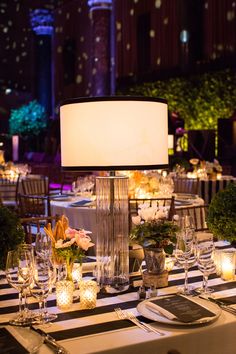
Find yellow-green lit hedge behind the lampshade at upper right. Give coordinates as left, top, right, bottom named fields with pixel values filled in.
left=123, top=69, right=236, bottom=129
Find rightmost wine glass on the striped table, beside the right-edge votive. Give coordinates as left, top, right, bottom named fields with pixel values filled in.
left=196, top=238, right=216, bottom=295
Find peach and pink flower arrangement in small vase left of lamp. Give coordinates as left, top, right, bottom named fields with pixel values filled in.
left=44, top=215, right=94, bottom=280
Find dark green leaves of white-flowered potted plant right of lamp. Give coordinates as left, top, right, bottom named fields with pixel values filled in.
left=130, top=219, right=178, bottom=253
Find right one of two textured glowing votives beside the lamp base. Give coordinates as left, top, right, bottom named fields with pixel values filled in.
left=79, top=280, right=98, bottom=309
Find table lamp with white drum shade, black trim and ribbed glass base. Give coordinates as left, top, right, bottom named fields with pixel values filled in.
left=60, top=96, right=168, bottom=293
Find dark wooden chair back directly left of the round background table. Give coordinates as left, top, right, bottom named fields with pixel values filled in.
left=18, top=194, right=51, bottom=218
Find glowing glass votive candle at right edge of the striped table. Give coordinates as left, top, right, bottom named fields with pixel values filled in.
left=221, top=250, right=236, bottom=280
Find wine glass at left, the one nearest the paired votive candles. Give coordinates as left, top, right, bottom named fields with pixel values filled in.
left=31, top=256, right=57, bottom=324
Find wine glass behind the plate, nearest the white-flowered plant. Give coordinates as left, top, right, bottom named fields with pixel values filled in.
left=175, top=229, right=196, bottom=295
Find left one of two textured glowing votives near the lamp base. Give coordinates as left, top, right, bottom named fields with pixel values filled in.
left=56, top=280, right=74, bottom=310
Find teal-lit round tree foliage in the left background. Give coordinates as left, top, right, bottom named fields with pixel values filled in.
left=9, top=100, right=47, bottom=136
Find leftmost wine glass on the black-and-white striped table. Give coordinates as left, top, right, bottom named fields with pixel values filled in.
left=5, top=247, right=34, bottom=326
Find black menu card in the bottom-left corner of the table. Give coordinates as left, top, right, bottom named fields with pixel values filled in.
left=0, top=328, right=29, bottom=354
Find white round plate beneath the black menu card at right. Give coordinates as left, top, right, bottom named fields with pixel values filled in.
left=137, top=296, right=221, bottom=326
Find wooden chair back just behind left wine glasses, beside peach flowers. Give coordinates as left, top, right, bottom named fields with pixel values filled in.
left=20, top=215, right=60, bottom=243
